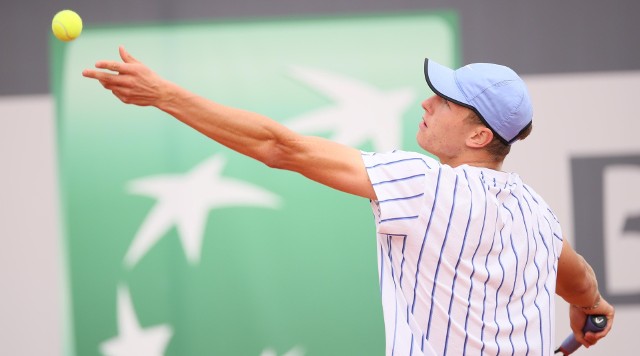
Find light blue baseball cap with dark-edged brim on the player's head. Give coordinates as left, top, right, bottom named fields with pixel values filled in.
left=424, top=58, right=533, bottom=144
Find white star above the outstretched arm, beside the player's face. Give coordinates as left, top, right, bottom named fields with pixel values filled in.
left=287, top=67, right=416, bottom=152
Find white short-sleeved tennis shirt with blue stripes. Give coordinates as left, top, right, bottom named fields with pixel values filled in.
left=362, top=151, right=562, bottom=355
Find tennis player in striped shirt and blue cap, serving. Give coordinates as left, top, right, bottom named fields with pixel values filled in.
left=83, top=47, right=614, bottom=355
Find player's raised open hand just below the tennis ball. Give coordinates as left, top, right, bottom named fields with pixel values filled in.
left=82, top=46, right=168, bottom=106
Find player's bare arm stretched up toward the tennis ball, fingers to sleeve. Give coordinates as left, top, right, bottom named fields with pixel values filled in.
left=82, top=47, right=376, bottom=200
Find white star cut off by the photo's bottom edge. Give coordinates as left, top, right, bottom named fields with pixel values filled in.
left=100, top=286, right=173, bottom=356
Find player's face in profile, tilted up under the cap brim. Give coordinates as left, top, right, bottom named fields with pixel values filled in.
left=416, top=95, right=474, bottom=162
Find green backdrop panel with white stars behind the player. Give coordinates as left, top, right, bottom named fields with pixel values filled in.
left=51, top=11, right=460, bottom=356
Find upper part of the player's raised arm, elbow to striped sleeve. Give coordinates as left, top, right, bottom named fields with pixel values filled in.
left=269, top=134, right=376, bottom=200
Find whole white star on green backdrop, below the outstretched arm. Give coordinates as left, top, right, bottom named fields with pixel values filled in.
left=124, top=156, right=280, bottom=268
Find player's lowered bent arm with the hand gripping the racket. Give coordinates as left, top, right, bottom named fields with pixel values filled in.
left=556, top=239, right=615, bottom=347
